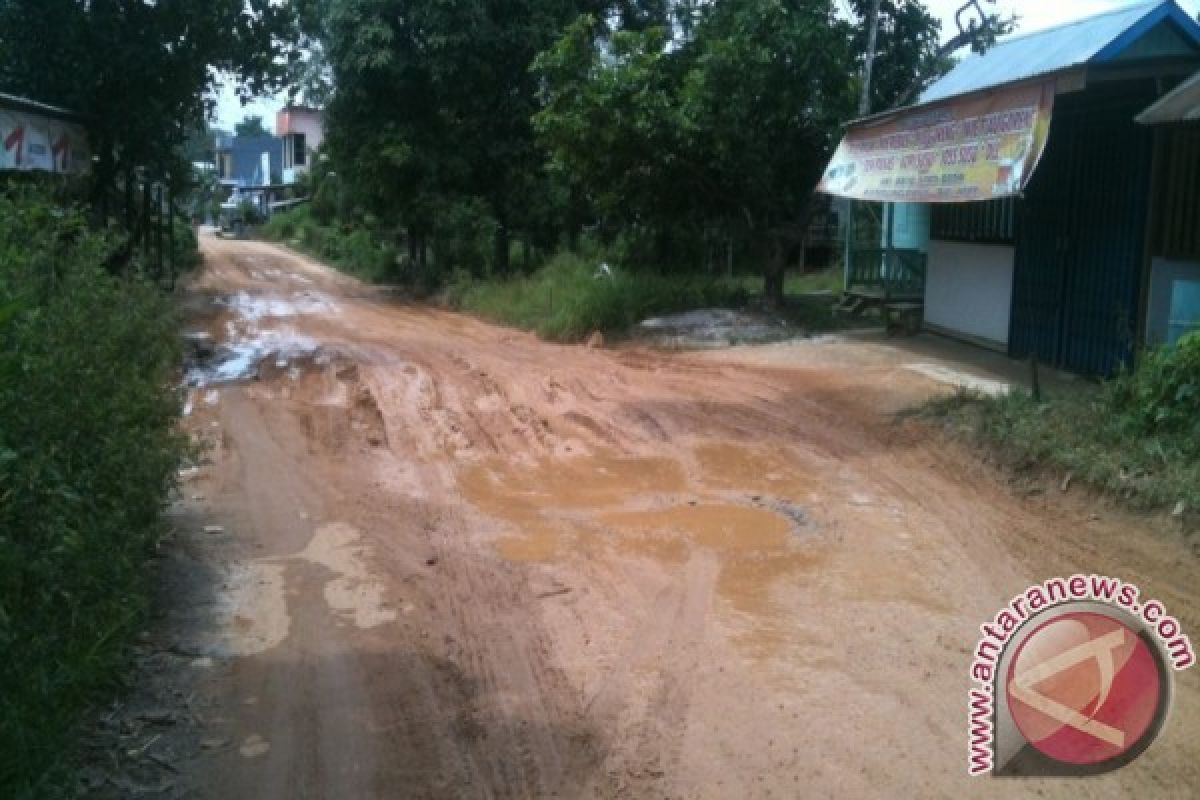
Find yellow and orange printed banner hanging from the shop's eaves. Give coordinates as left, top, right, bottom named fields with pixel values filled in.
left=817, top=80, right=1055, bottom=203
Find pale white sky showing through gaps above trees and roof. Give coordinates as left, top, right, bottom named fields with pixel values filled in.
left=217, top=0, right=1200, bottom=130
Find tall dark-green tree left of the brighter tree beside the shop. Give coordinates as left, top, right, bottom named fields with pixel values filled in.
left=323, top=0, right=644, bottom=273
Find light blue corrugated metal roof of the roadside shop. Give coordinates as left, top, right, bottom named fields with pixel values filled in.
left=920, top=0, right=1200, bottom=104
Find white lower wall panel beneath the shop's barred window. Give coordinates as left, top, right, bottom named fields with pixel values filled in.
left=925, top=239, right=1014, bottom=345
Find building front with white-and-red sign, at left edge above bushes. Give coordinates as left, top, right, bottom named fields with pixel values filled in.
left=0, top=94, right=91, bottom=174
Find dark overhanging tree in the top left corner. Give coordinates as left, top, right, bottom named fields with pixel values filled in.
left=0, top=0, right=295, bottom=221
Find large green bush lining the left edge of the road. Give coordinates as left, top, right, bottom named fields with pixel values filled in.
left=0, top=190, right=184, bottom=796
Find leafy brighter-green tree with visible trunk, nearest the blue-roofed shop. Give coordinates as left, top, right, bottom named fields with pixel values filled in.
left=535, top=0, right=854, bottom=302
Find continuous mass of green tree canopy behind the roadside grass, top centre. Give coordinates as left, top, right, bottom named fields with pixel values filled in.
left=280, top=0, right=1001, bottom=294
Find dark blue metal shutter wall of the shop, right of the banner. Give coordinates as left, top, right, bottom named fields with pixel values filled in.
left=1009, top=83, right=1156, bottom=375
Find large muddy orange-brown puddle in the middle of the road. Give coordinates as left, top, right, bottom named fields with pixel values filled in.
left=460, top=445, right=827, bottom=652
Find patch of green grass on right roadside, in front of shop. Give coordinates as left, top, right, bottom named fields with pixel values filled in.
left=923, top=385, right=1200, bottom=510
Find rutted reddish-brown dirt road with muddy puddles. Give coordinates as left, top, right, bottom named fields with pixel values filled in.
left=164, top=230, right=1200, bottom=800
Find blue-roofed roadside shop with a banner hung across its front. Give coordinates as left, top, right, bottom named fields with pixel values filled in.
left=821, top=0, right=1200, bottom=374
